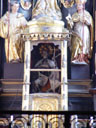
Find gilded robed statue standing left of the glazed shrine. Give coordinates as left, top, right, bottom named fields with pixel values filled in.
left=0, top=1, right=27, bottom=62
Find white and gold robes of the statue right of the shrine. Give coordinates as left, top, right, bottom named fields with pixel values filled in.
left=71, top=10, right=93, bottom=63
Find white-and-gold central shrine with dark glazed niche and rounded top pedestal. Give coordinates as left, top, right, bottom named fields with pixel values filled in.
left=22, top=1, right=69, bottom=111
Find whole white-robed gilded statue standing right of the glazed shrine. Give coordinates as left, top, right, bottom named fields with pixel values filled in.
left=66, top=0, right=93, bottom=64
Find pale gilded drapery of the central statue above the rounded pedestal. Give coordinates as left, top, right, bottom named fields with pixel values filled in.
left=32, top=0, right=62, bottom=20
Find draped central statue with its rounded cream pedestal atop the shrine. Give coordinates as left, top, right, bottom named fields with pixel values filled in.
left=28, top=0, right=73, bottom=33
